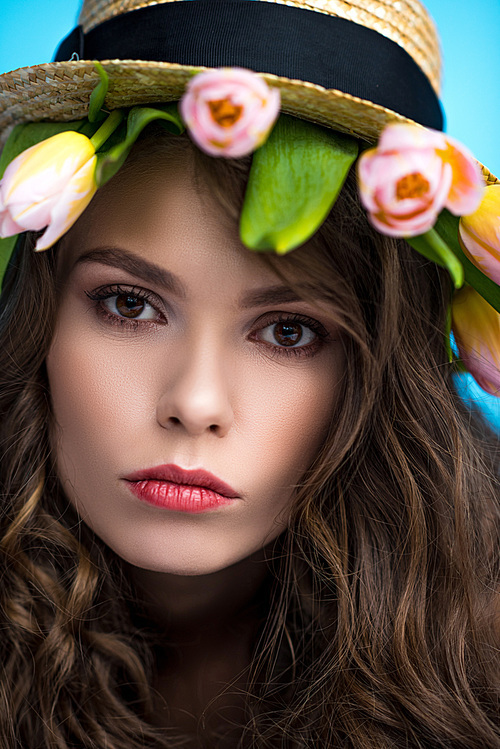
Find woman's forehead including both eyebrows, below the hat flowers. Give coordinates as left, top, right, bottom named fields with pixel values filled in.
left=54, top=139, right=344, bottom=320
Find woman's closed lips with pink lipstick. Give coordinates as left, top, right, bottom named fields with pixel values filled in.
left=124, top=464, right=239, bottom=513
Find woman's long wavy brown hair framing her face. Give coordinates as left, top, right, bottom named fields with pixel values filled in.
left=0, top=132, right=500, bottom=749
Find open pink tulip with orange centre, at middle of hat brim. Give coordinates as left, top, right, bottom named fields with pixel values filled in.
left=180, top=68, right=280, bottom=158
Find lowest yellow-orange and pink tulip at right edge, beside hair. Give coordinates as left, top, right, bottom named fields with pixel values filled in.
left=452, top=286, right=500, bottom=396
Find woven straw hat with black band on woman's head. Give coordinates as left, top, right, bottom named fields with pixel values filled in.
left=0, top=0, right=442, bottom=143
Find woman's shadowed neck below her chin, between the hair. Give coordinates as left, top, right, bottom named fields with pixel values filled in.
left=124, top=550, right=278, bottom=747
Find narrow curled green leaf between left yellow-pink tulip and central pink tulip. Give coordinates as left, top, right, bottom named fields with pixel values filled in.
left=96, top=102, right=184, bottom=187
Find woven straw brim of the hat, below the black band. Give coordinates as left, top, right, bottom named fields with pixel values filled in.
left=0, top=60, right=499, bottom=184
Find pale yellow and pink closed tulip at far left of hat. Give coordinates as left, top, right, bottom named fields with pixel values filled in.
left=0, top=130, right=97, bottom=250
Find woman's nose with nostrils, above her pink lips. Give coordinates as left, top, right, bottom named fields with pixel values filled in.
left=157, top=341, right=233, bottom=437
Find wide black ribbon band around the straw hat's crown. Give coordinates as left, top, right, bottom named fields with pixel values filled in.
left=55, top=0, right=443, bottom=130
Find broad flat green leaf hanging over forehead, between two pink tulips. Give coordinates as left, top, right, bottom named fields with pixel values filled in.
left=240, top=115, right=358, bottom=254
